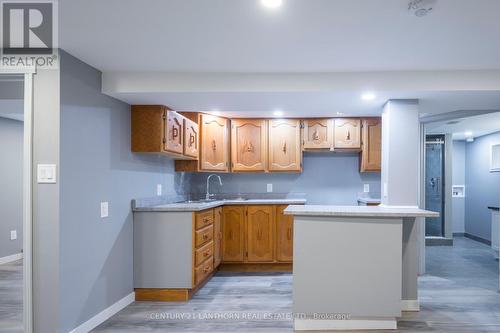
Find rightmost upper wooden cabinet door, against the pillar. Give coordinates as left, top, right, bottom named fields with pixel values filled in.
left=361, top=118, right=382, bottom=172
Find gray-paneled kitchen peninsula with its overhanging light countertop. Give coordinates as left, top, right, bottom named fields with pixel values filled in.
left=285, top=205, right=439, bottom=330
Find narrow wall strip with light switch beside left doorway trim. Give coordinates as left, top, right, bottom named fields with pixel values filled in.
left=32, top=70, right=60, bottom=332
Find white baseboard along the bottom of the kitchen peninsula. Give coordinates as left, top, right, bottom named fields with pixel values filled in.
left=293, top=318, right=398, bottom=331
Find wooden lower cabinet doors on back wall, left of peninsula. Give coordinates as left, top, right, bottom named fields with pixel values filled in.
left=222, top=205, right=293, bottom=267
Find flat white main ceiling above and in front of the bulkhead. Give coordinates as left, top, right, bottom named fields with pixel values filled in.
left=59, top=0, right=500, bottom=72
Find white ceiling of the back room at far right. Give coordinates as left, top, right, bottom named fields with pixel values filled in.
left=426, top=112, right=500, bottom=140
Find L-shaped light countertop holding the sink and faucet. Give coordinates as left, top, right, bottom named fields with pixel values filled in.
left=134, top=198, right=306, bottom=212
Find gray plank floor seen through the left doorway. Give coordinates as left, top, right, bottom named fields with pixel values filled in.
left=0, top=260, right=23, bottom=333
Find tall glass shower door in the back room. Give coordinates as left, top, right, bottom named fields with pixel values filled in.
left=425, top=135, right=445, bottom=237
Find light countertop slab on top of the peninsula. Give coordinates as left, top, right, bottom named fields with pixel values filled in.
left=285, top=205, right=439, bottom=218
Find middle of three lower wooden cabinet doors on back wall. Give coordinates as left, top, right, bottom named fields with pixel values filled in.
left=247, top=205, right=275, bottom=262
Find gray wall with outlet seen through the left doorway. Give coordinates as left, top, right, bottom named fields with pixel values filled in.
left=0, top=118, right=24, bottom=258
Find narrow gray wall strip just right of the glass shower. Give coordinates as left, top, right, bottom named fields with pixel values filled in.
left=451, top=141, right=467, bottom=234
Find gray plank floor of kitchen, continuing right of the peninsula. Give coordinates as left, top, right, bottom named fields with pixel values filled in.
left=93, top=238, right=500, bottom=333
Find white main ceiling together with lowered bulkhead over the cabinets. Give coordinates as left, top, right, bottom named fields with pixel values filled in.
left=59, top=0, right=500, bottom=117
